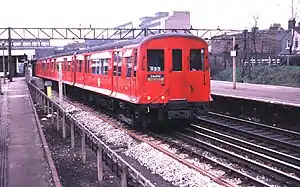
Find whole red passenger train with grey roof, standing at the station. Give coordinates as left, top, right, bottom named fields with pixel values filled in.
left=35, top=34, right=211, bottom=125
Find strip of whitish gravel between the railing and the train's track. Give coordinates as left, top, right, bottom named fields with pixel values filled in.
left=54, top=95, right=224, bottom=187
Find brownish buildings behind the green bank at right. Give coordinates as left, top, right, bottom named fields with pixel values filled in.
left=210, top=20, right=300, bottom=68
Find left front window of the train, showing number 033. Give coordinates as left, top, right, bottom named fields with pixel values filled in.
left=147, top=49, right=165, bottom=72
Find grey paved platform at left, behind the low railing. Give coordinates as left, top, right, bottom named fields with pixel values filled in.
left=0, top=78, right=55, bottom=187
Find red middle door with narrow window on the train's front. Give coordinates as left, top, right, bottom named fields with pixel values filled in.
left=166, top=48, right=187, bottom=100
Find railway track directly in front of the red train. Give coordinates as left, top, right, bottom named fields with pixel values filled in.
left=143, top=130, right=300, bottom=186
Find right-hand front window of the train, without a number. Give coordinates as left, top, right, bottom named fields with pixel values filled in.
left=190, top=49, right=204, bottom=71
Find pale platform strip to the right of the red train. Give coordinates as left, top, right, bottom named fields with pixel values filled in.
left=211, top=80, right=300, bottom=107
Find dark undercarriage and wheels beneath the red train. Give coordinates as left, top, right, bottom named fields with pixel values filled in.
left=48, top=79, right=207, bottom=128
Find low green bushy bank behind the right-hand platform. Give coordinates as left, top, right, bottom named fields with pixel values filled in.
left=212, top=66, right=300, bottom=87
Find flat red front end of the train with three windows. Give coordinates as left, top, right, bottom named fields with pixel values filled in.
left=141, top=36, right=210, bottom=120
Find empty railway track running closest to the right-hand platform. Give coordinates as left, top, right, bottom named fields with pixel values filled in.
left=198, top=113, right=300, bottom=166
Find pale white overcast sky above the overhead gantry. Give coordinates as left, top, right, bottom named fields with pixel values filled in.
left=0, top=0, right=300, bottom=29
